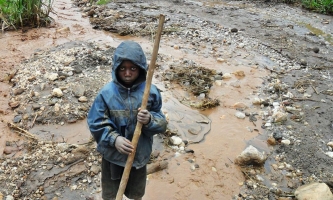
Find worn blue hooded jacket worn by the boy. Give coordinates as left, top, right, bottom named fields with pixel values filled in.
left=87, top=41, right=167, bottom=168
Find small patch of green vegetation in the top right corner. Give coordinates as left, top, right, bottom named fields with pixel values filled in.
left=302, top=0, right=333, bottom=14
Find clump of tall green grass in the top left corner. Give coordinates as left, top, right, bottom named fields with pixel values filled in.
left=0, top=0, right=52, bottom=30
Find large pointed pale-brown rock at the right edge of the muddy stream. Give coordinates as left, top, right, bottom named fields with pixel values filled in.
left=235, top=145, right=267, bottom=165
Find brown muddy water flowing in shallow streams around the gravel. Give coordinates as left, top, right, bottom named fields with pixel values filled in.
left=0, top=0, right=266, bottom=200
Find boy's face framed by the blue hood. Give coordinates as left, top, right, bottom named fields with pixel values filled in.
left=117, top=60, right=140, bottom=87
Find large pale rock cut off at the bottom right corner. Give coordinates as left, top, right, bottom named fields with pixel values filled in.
left=295, top=182, right=333, bottom=200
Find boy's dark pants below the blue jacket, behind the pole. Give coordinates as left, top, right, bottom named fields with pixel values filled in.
left=102, top=158, right=147, bottom=200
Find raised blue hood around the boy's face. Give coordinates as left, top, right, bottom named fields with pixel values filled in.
left=111, top=41, right=148, bottom=86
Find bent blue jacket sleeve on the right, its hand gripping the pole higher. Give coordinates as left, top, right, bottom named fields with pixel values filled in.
left=142, top=88, right=167, bottom=136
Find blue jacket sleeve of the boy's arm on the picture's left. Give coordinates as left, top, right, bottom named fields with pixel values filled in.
left=87, top=93, right=119, bottom=147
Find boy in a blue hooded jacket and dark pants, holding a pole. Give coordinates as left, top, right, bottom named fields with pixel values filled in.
left=87, top=41, right=167, bottom=200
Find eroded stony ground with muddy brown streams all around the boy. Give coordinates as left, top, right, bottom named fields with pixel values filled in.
left=0, top=1, right=333, bottom=199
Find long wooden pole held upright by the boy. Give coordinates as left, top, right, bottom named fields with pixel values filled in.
left=116, top=15, right=165, bottom=200
